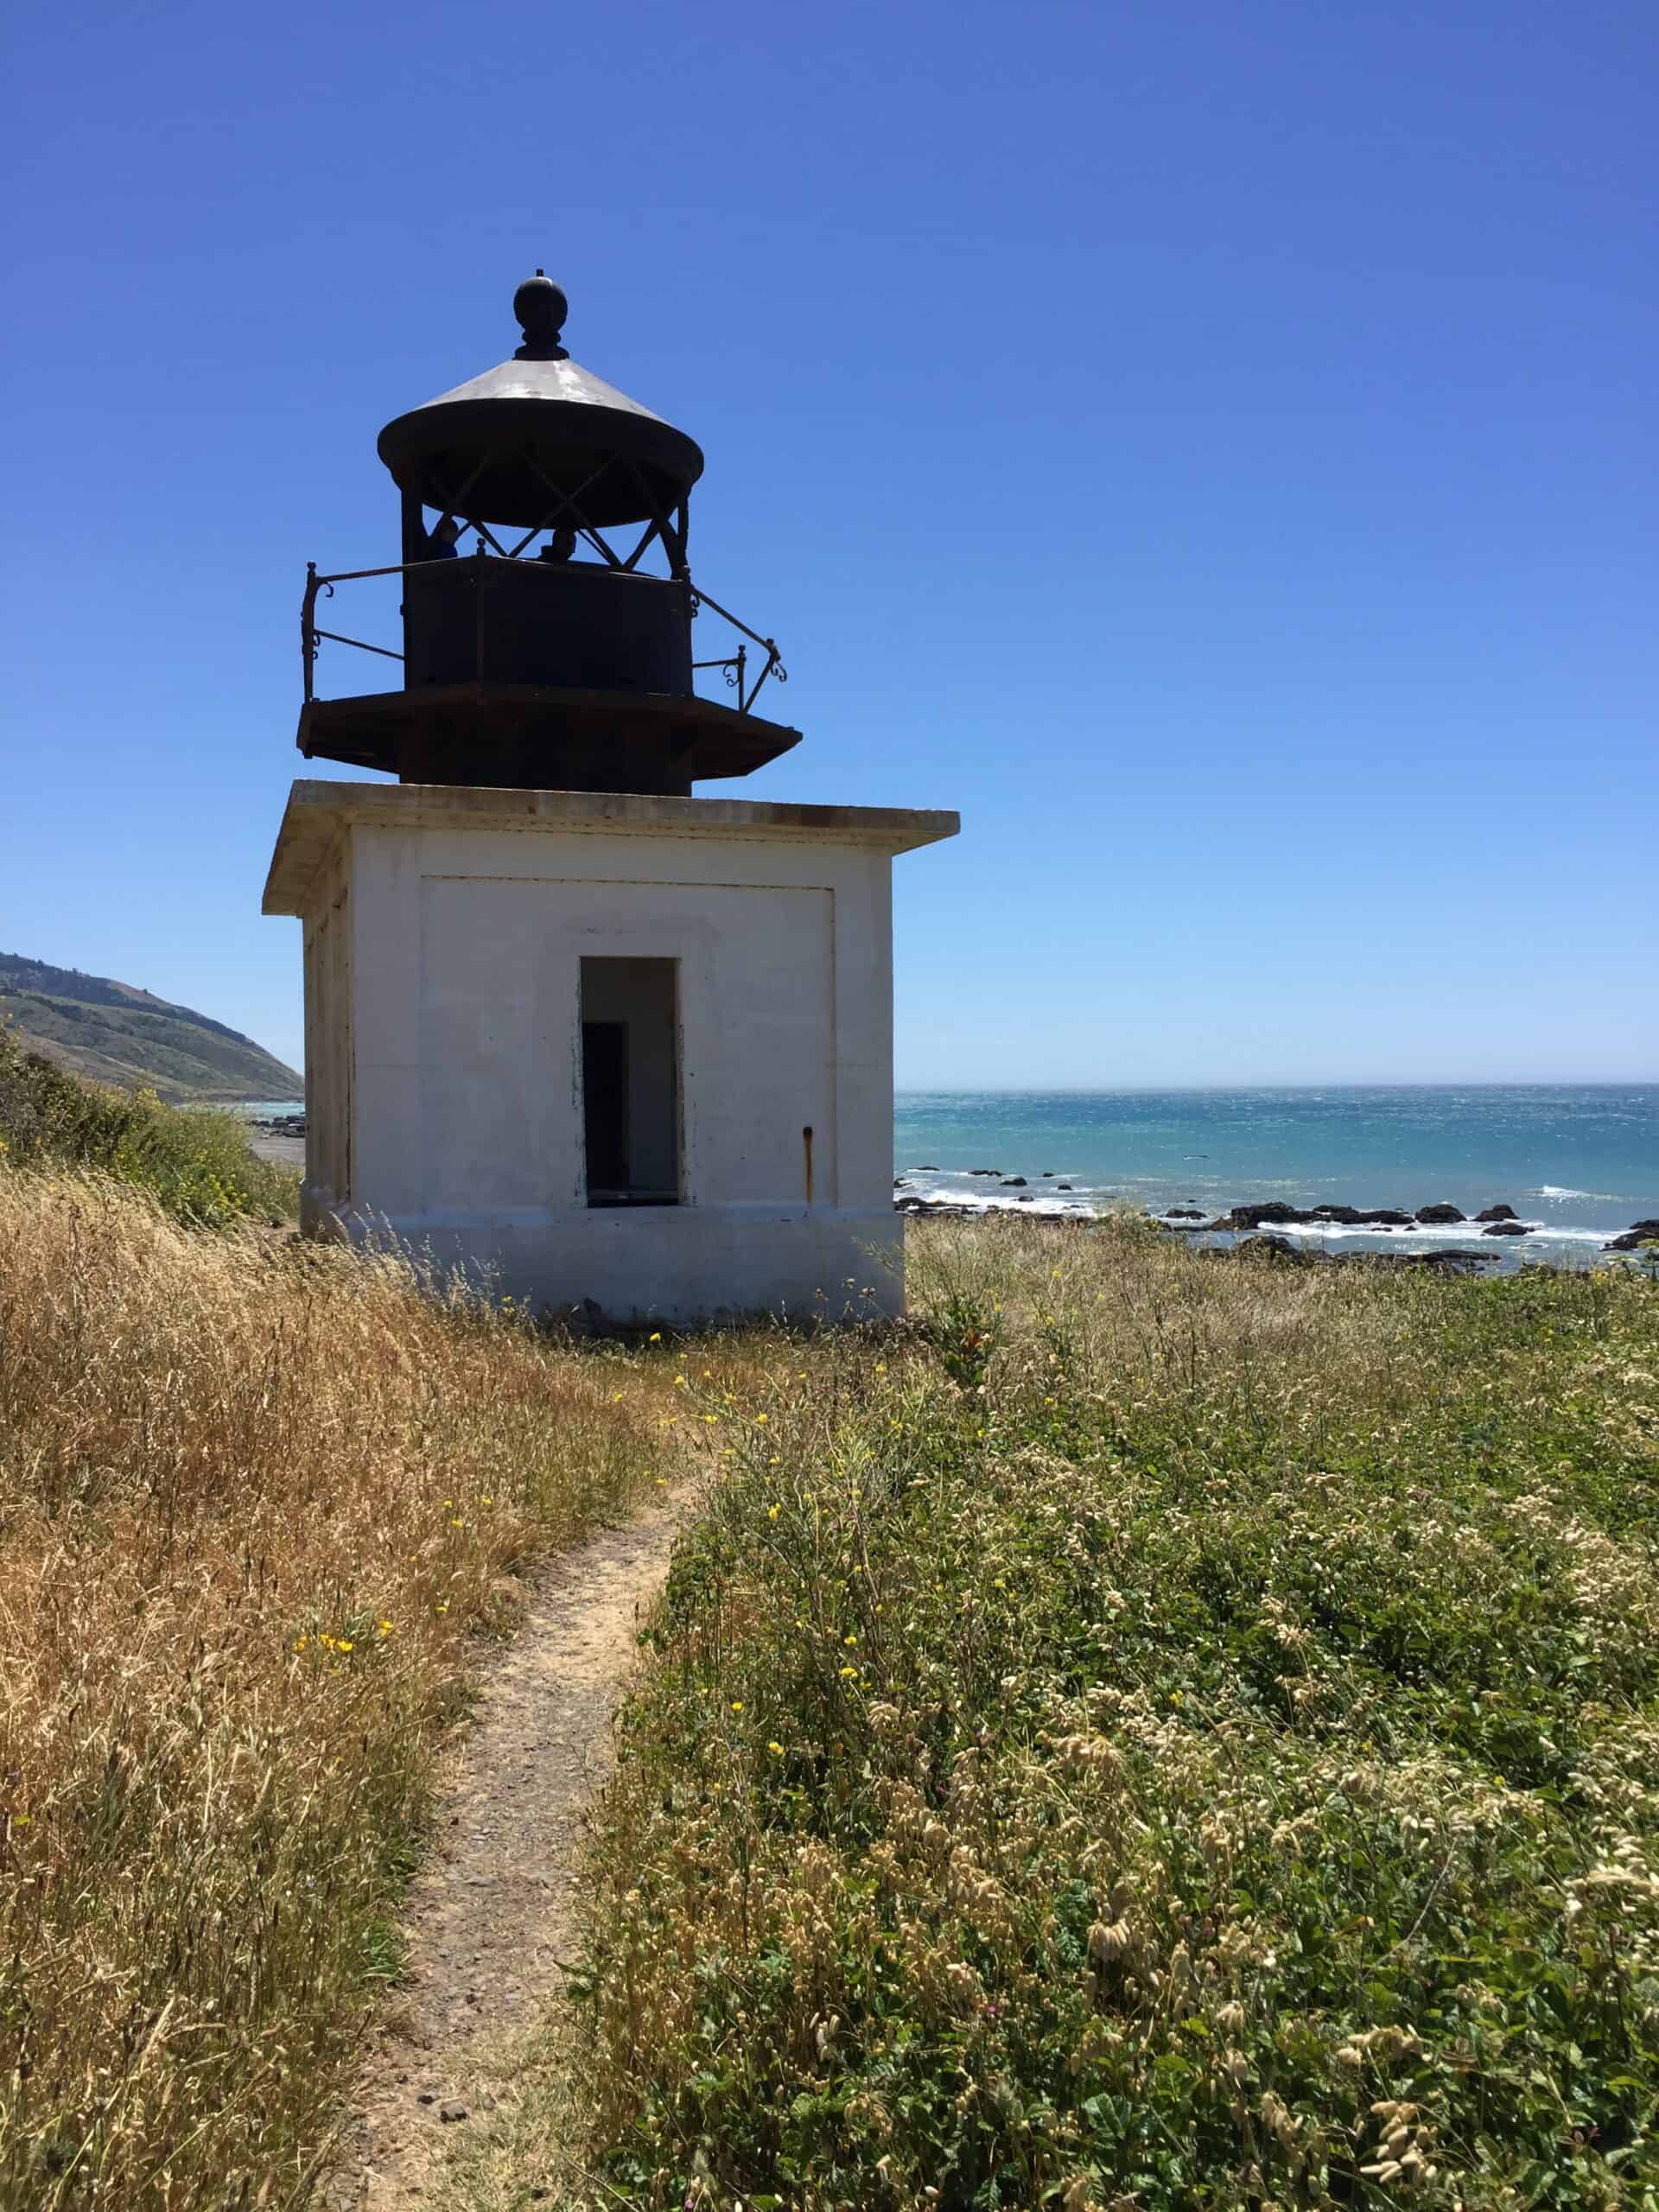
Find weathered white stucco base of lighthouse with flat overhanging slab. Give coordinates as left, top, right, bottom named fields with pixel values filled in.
left=265, top=783, right=956, bottom=1320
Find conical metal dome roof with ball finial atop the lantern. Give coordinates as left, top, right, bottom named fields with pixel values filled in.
left=378, top=270, right=703, bottom=529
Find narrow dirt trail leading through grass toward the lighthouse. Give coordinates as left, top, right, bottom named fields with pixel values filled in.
left=329, top=1497, right=688, bottom=2212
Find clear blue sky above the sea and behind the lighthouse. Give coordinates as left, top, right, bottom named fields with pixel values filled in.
left=0, top=0, right=1659, bottom=1086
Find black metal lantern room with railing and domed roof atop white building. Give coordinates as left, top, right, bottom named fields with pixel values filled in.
left=299, top=270, right=801, bottom=794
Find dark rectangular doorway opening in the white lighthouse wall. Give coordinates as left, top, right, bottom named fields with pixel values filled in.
left=582, top=960, right=679, bottom=1205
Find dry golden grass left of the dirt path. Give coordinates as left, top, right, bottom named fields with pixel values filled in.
left=0, top=1173, right=672, bottom=2212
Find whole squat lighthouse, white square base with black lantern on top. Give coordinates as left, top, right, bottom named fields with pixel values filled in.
left=264, top=270, right=960, bottom=1325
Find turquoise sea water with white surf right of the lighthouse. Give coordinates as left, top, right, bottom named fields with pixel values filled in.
left=893, top=1084, right=1659, bottom=1265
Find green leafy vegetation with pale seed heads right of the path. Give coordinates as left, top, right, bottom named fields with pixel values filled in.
left=562, top=1224, right=1659, bottom=2212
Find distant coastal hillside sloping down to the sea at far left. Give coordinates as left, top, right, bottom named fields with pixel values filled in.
left=0, top=953, right=301, bottom=1103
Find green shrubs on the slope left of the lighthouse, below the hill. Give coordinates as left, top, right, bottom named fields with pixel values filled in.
left=0, top=1024, right=299, bottom=1228
